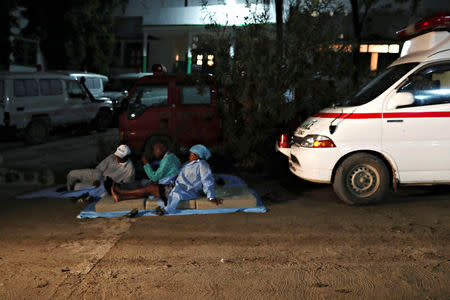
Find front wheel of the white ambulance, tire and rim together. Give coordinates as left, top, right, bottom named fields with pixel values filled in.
left=333, top=153, right=389, bottom=205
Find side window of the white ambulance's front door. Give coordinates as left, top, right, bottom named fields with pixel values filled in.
left=399, top=64, right=450, bottom=106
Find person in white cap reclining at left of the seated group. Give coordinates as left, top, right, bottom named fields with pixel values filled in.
left=67, top=145, right=135, bottom=191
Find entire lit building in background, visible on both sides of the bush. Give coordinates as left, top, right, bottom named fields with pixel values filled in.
left=112, top=0, right=445, bottom=73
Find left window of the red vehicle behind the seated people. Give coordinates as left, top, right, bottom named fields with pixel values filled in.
left=130, top=86, right=169, bottom=106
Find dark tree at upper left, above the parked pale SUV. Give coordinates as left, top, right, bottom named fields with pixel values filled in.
left=21, top=0, right=128, bottom=73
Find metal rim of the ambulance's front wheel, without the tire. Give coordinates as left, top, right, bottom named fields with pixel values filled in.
left=347, top=165, right=379, bottom=197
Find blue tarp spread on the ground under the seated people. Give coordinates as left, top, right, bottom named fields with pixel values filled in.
left=17, top=174, right=267, bottom=219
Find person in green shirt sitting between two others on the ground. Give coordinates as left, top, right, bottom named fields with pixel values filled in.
left=120, top=141, right=181, bottom=190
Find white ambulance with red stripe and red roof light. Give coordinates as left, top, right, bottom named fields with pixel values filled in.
left=276, top=13, right=450, bottom=204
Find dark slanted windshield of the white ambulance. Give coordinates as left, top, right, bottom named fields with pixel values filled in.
left=341, top=63, right=418, bottom=106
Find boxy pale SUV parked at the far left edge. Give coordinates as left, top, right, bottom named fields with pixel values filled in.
left=0, top=72, right=113, bottom=144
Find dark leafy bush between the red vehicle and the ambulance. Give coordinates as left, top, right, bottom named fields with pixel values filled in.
left=197, top=0, right=348, bottom=167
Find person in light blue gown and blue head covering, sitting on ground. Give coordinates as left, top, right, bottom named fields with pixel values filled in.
left=111, top=145, right=223, bottom=214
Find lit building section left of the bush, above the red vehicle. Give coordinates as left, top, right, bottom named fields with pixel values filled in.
left=112, top=0, right=275, bottom=73
